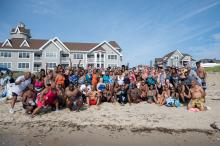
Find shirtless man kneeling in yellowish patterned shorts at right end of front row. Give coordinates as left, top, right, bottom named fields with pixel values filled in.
left=188, top=80, right=205, bottom=111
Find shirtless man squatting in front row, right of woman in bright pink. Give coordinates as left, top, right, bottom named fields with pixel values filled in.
left=65, top=84, right=83, bottom=112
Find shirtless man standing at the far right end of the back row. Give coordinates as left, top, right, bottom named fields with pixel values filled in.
left=196, top=61, right=207, bottom=90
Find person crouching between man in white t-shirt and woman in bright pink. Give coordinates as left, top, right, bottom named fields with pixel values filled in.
left=22, top=84, right=36, bottom=114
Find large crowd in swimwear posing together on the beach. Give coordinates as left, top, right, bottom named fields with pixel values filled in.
left=0, top=62, right=206, bottom=117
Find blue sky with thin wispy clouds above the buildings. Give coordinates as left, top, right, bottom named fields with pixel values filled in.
left=0, top=0, right=220, bottom=65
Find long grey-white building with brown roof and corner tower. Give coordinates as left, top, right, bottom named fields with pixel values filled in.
left=0, top=23, right=122, bottom=71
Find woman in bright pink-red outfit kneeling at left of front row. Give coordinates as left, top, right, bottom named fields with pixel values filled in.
left=32, top=81, right=59, bottom=117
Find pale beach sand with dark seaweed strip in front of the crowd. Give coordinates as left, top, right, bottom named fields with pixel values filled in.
left=0, top=73, right=220, bottom=146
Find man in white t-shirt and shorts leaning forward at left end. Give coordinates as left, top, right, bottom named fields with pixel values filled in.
left=9, top=72, right=31, bottom=113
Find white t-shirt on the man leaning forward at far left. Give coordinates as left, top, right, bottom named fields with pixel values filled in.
left=12, top=76, right=31, bottom=95
